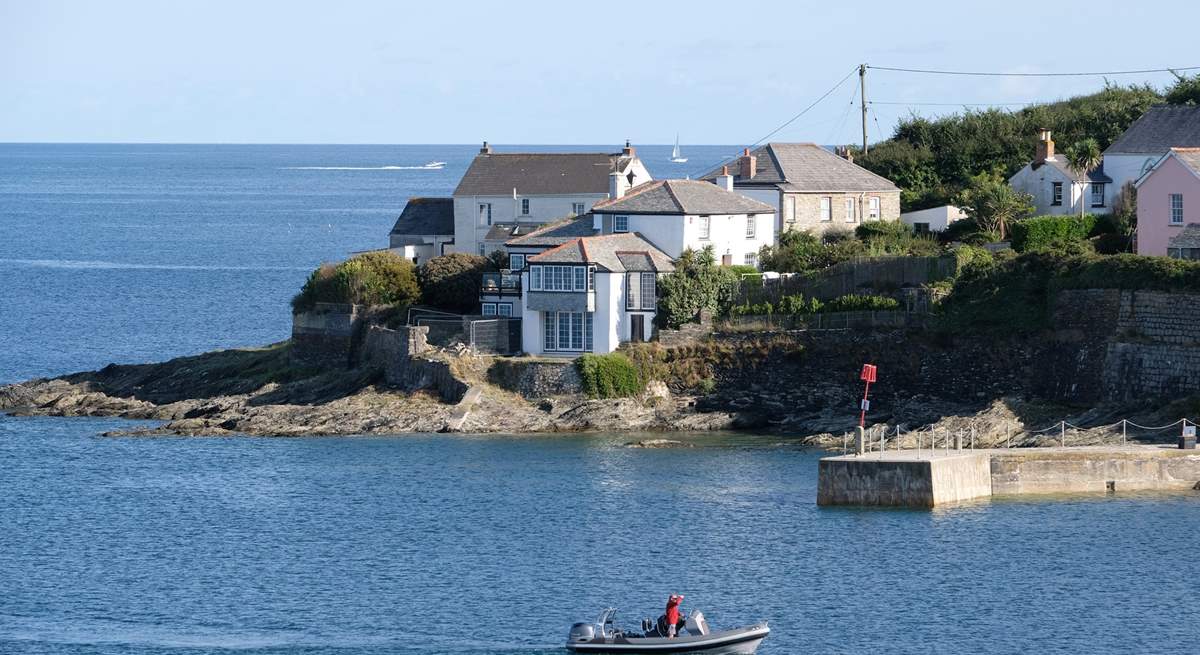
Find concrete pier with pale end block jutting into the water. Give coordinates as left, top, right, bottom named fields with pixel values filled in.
left=817, top=445, right=1200, bottom=507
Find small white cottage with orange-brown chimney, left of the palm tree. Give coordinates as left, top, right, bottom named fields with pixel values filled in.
left=1008, top=130, right=1115, bottom=216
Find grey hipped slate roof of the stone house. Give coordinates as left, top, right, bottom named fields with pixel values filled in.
left=701, top=143, right=900, bottom=193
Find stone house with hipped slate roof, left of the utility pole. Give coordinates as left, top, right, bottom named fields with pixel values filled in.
left=701, top=143, right=900, bottom=234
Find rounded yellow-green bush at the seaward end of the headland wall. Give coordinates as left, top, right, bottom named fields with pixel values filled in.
left=292, top=251, right=421, bottom=313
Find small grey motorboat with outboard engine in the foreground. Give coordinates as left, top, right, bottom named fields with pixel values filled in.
left=566, top=607, right=770, bottom=655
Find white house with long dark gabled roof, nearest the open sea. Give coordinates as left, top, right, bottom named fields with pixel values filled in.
left=452, top=142, right=650, bottom=254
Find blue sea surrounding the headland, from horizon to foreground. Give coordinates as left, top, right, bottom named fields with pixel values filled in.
left=0, top=144, right=1200, bottom=655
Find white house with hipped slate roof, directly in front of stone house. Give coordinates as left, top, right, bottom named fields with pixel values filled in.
left=592, top=175, right=775, bottom=266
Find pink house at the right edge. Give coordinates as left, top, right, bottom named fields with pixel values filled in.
left=1134, top=148, right=1200, bottom=259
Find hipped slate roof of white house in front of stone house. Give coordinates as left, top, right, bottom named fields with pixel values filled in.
left=592, top=180, right=775, bottom=215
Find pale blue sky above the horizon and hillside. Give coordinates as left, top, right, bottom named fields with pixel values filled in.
left=0, top=0, right=1200, bottom=144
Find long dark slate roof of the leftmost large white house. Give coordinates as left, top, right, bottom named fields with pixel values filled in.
left=454, top=152, right=634, bottom=196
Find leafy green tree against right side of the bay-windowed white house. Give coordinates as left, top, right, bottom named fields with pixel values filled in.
left=658, top=246, right=738, bottom=328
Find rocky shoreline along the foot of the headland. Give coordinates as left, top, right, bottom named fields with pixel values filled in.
left=0, top=337, right=1180, bottom=450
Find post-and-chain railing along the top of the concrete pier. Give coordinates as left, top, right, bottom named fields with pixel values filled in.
left=842, top=417, right=1200, bottom=457
